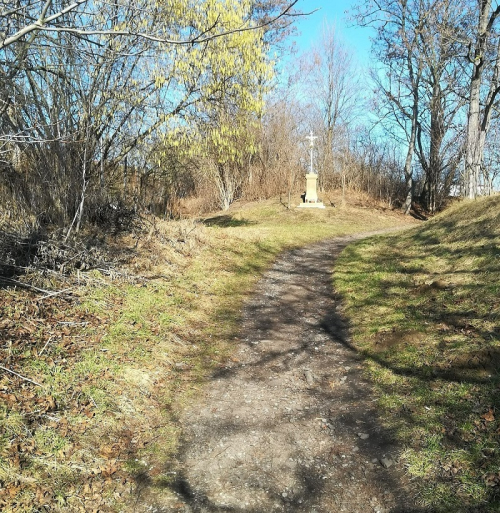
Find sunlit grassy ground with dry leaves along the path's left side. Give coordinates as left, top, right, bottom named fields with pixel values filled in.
left=0, top=194, right=411, bottom=513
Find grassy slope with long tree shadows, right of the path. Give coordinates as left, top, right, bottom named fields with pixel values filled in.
left=335, top=197, right=500, bottom=511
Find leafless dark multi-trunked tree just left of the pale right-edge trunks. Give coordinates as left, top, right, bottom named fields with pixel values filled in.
left=356, top=0, right=467, bottom=213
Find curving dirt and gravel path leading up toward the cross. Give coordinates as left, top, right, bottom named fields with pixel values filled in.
left=157, top=235, right=422, bottom=513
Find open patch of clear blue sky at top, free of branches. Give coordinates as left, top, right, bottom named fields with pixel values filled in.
left=295, top=0, right=371, bottom=64
